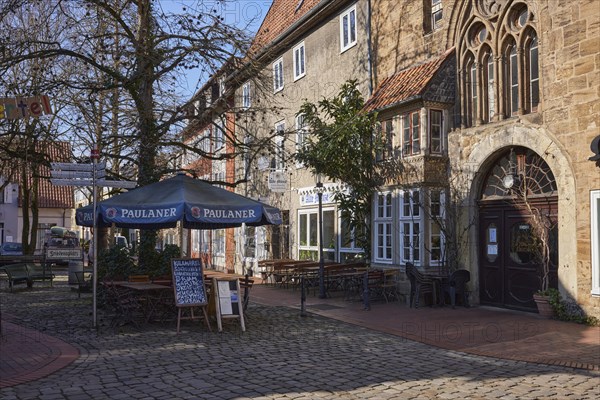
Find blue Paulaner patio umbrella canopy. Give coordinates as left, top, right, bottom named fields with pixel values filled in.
left=75, top=174, right=281, bottom=229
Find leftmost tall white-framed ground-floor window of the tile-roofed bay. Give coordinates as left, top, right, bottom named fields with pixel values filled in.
left=373, top=193, right=392, bottom=263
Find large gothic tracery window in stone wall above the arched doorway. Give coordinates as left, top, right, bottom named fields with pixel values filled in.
left=458, top=1, right=541, bottom=126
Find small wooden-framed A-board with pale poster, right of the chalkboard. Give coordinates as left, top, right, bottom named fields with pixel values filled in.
left=212, top=277, right=246, bottom=332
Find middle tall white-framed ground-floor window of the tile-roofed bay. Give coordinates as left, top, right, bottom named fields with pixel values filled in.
left=400, top=189, right=423, bottom=265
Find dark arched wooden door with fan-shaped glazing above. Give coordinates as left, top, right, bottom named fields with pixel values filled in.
left=479, top=147, right=558, bottom=311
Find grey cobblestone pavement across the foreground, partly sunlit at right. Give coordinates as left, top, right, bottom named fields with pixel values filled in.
left=0, top=277, right=600, bottom=400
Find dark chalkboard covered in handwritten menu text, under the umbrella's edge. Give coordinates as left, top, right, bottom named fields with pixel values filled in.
left=171, top=258, right=208, bottom=307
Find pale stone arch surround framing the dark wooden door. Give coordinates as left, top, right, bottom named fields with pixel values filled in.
left=458, top=120, right=577, bottom=302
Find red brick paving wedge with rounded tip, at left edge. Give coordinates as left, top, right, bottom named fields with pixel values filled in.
left=0, top=320, right=79, bottom=388
